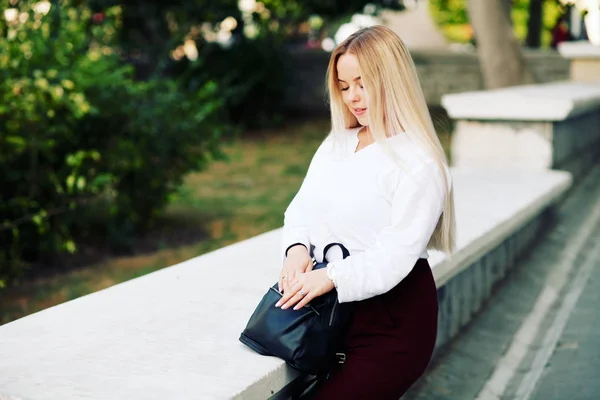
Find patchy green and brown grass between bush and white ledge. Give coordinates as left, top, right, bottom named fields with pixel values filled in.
left=0, top=113, right=450, bottom=324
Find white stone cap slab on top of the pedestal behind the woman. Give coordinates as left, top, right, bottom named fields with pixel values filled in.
left=442, top=82, right=600, bottom=121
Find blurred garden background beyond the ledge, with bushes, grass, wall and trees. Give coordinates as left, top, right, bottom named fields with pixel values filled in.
left=0, top=0, right=599, bottom=324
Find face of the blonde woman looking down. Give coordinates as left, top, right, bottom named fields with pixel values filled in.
left=336, top=53, right=369, bottom=126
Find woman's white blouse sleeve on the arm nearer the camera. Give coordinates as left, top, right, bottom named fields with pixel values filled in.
left=334, top=162, right=445, bottom=303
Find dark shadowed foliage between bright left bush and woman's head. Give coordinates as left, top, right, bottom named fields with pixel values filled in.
left=90, top=0, right=287, bottom=128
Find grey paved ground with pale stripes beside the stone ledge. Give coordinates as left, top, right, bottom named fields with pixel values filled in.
left=403, top=166, right=600, bottom=400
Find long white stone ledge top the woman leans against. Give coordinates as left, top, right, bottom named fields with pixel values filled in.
left=0, top=169, right=571, bottom=400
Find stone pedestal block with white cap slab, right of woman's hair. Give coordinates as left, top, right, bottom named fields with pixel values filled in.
left=442, top=82, right=600, bottom=178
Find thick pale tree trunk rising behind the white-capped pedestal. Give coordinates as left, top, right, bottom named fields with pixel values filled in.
left=468, top=0, right=533, bottom=89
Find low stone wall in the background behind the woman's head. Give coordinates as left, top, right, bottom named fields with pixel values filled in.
left=284, top=50, right=569, bottom=114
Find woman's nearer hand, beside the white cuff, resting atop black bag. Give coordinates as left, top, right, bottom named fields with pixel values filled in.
left=275, top=268, right=334, bottom=310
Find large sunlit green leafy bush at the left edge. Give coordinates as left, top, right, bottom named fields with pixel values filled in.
left=0, top=0, right=227, bottom=287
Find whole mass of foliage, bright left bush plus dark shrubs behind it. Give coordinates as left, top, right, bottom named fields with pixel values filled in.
left=0, top=0, right=412, bottom=287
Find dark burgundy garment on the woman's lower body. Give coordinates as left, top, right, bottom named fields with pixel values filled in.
left=311, top=259, right=438, bottom=400
